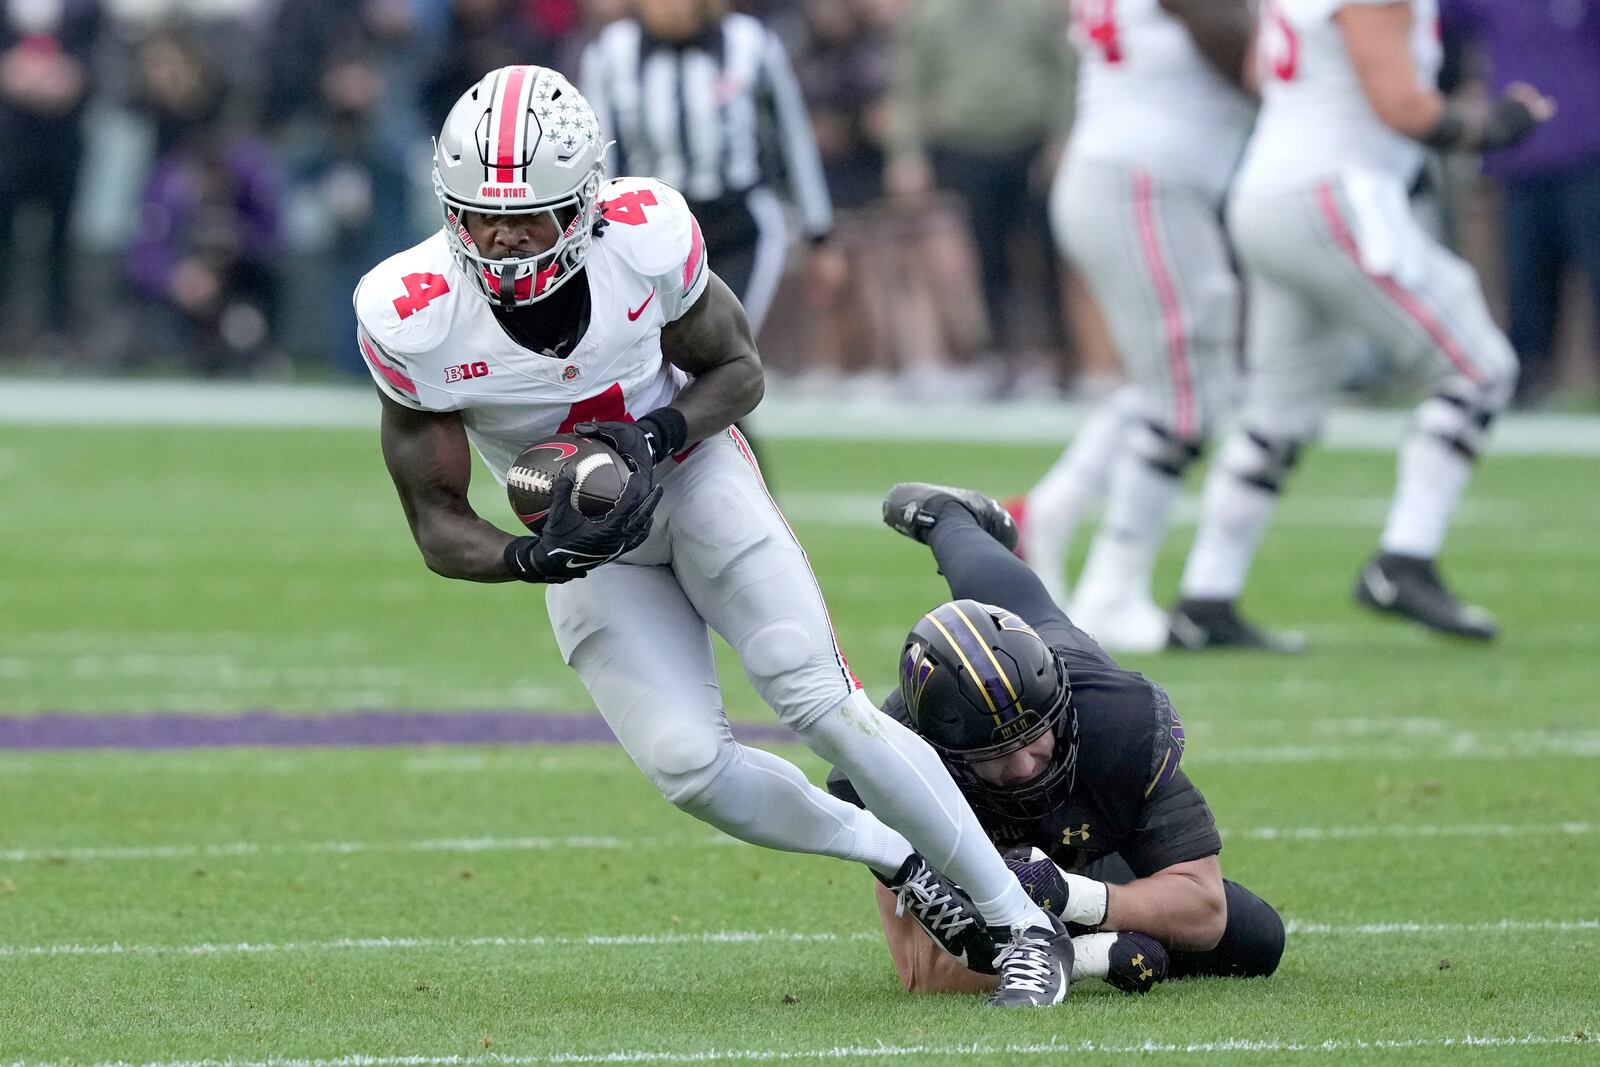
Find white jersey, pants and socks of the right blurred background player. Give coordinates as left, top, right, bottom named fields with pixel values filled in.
left=1182, top=0, right=1517, bottom=630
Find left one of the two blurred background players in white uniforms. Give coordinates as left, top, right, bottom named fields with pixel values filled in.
left=1022, top=0, right=1254, bottom=653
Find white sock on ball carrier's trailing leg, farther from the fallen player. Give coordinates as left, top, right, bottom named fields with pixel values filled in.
left=665, top=745, right=910, bottom=875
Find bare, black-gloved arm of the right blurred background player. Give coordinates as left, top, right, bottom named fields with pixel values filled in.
left=1333, top=0, right=1555, bottom=152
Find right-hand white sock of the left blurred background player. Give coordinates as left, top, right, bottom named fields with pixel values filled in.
left=1078, top=453, right=1184, bottom=601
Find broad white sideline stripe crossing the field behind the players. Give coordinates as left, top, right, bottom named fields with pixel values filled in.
left=0, top=379, right=1600, bottom=456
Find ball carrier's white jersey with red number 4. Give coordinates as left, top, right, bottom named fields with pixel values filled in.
left=355, top=178, right=710, bottom=483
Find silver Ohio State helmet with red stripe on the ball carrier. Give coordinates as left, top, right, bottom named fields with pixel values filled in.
left=434, top=67, right=605, bottom=307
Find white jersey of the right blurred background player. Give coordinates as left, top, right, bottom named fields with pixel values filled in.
left=1238, top=0, right=1443, bottom=192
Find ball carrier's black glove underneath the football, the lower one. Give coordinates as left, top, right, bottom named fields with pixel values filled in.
left=506, top=469, right=661, bottom=585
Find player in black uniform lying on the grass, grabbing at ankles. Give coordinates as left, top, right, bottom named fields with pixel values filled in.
left=827, top=483, right=1283, bottom=992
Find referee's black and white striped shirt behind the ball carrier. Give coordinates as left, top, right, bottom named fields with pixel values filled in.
left=579, top=14, right=834, bottom=237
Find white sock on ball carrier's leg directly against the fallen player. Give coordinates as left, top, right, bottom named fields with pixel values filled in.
left=800, top=691, right=1048, bottom=928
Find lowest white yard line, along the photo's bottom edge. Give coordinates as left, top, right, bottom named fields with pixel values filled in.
left=0, top=1033, right=1594, bottom=1067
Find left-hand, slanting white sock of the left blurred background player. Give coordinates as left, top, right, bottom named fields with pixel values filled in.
left=1022, top=387, right=1138, bottom=603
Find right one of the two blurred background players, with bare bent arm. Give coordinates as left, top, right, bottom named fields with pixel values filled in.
left=1171, top=0, right=1554, bottom=649
